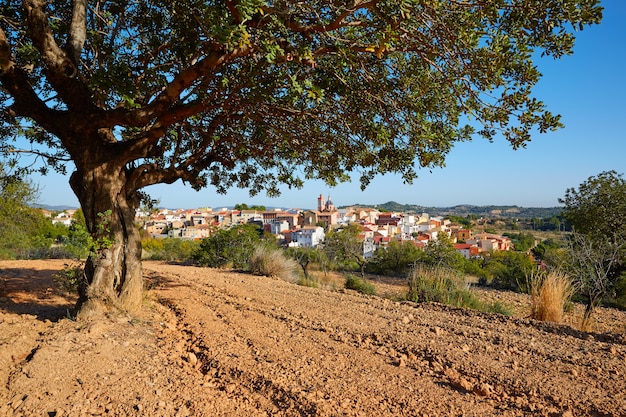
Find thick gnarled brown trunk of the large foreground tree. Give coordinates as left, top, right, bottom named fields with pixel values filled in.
left=70, top=164, right=143, bottom=318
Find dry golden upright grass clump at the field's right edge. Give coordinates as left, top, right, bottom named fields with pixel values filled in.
left=528, top=271, right=575, bottom=323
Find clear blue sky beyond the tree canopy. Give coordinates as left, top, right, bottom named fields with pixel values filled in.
left=32, top=0, right=626, bottom=208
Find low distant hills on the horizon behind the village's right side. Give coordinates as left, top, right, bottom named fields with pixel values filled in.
left=342, top=201, right=562, bottom=219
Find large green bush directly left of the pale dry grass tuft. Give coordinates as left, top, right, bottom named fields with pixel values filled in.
left=192, top=224, right=262, bottom=269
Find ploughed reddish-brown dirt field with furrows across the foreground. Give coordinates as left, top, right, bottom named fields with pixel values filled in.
left=0, top=260, right=626, bottom=416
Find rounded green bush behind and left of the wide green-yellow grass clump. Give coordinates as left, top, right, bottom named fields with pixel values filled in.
left=366, top=240, right=425, bottom=276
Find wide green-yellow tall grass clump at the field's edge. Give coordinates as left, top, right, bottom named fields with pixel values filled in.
left=407, top=265, right=485, bottom=310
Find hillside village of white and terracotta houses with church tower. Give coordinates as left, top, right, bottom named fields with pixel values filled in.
left=52, top=194, right=512, bottom=258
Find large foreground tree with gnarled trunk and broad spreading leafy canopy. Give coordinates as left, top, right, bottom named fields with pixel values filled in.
left=0, top=0, right=602, bottom=315
